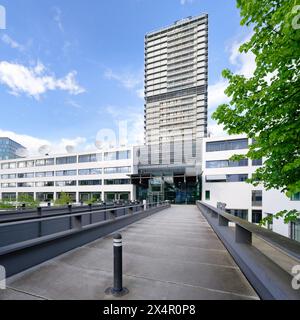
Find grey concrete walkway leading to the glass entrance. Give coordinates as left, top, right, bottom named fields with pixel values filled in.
left=0, top=206, right=258, bottom=300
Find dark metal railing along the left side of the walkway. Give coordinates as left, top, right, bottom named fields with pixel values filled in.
left=0, top=202, right=170, bottom=276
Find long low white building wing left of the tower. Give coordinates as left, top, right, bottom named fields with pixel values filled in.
left=0, top=147, right=135, bottom=202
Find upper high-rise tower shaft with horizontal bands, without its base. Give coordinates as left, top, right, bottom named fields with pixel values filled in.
left=145, top=14, right=208, bottom=145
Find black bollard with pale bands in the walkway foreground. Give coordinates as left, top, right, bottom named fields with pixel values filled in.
left=105, top=233, right=129, bottom=297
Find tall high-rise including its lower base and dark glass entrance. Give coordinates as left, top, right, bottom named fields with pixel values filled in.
left=132, top=14, right=208, bottom=203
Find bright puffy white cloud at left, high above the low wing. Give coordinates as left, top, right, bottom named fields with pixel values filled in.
left=0, top=61, right=85, bottom=99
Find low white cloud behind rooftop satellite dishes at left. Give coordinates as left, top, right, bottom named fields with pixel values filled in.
left=0, top=129, right=86, bottom=156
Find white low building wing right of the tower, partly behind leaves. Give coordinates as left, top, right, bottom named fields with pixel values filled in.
left=202, top=136, right=300, bottom=241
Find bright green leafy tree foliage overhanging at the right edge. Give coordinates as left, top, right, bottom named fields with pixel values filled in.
left=213, top=0, right=300, bottom=224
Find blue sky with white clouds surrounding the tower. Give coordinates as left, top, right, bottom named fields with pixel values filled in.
left=0, top=0, right=255, bottom=153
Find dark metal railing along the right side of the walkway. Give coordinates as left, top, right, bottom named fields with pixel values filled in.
left=197, top=201, right=300, bottom=300
